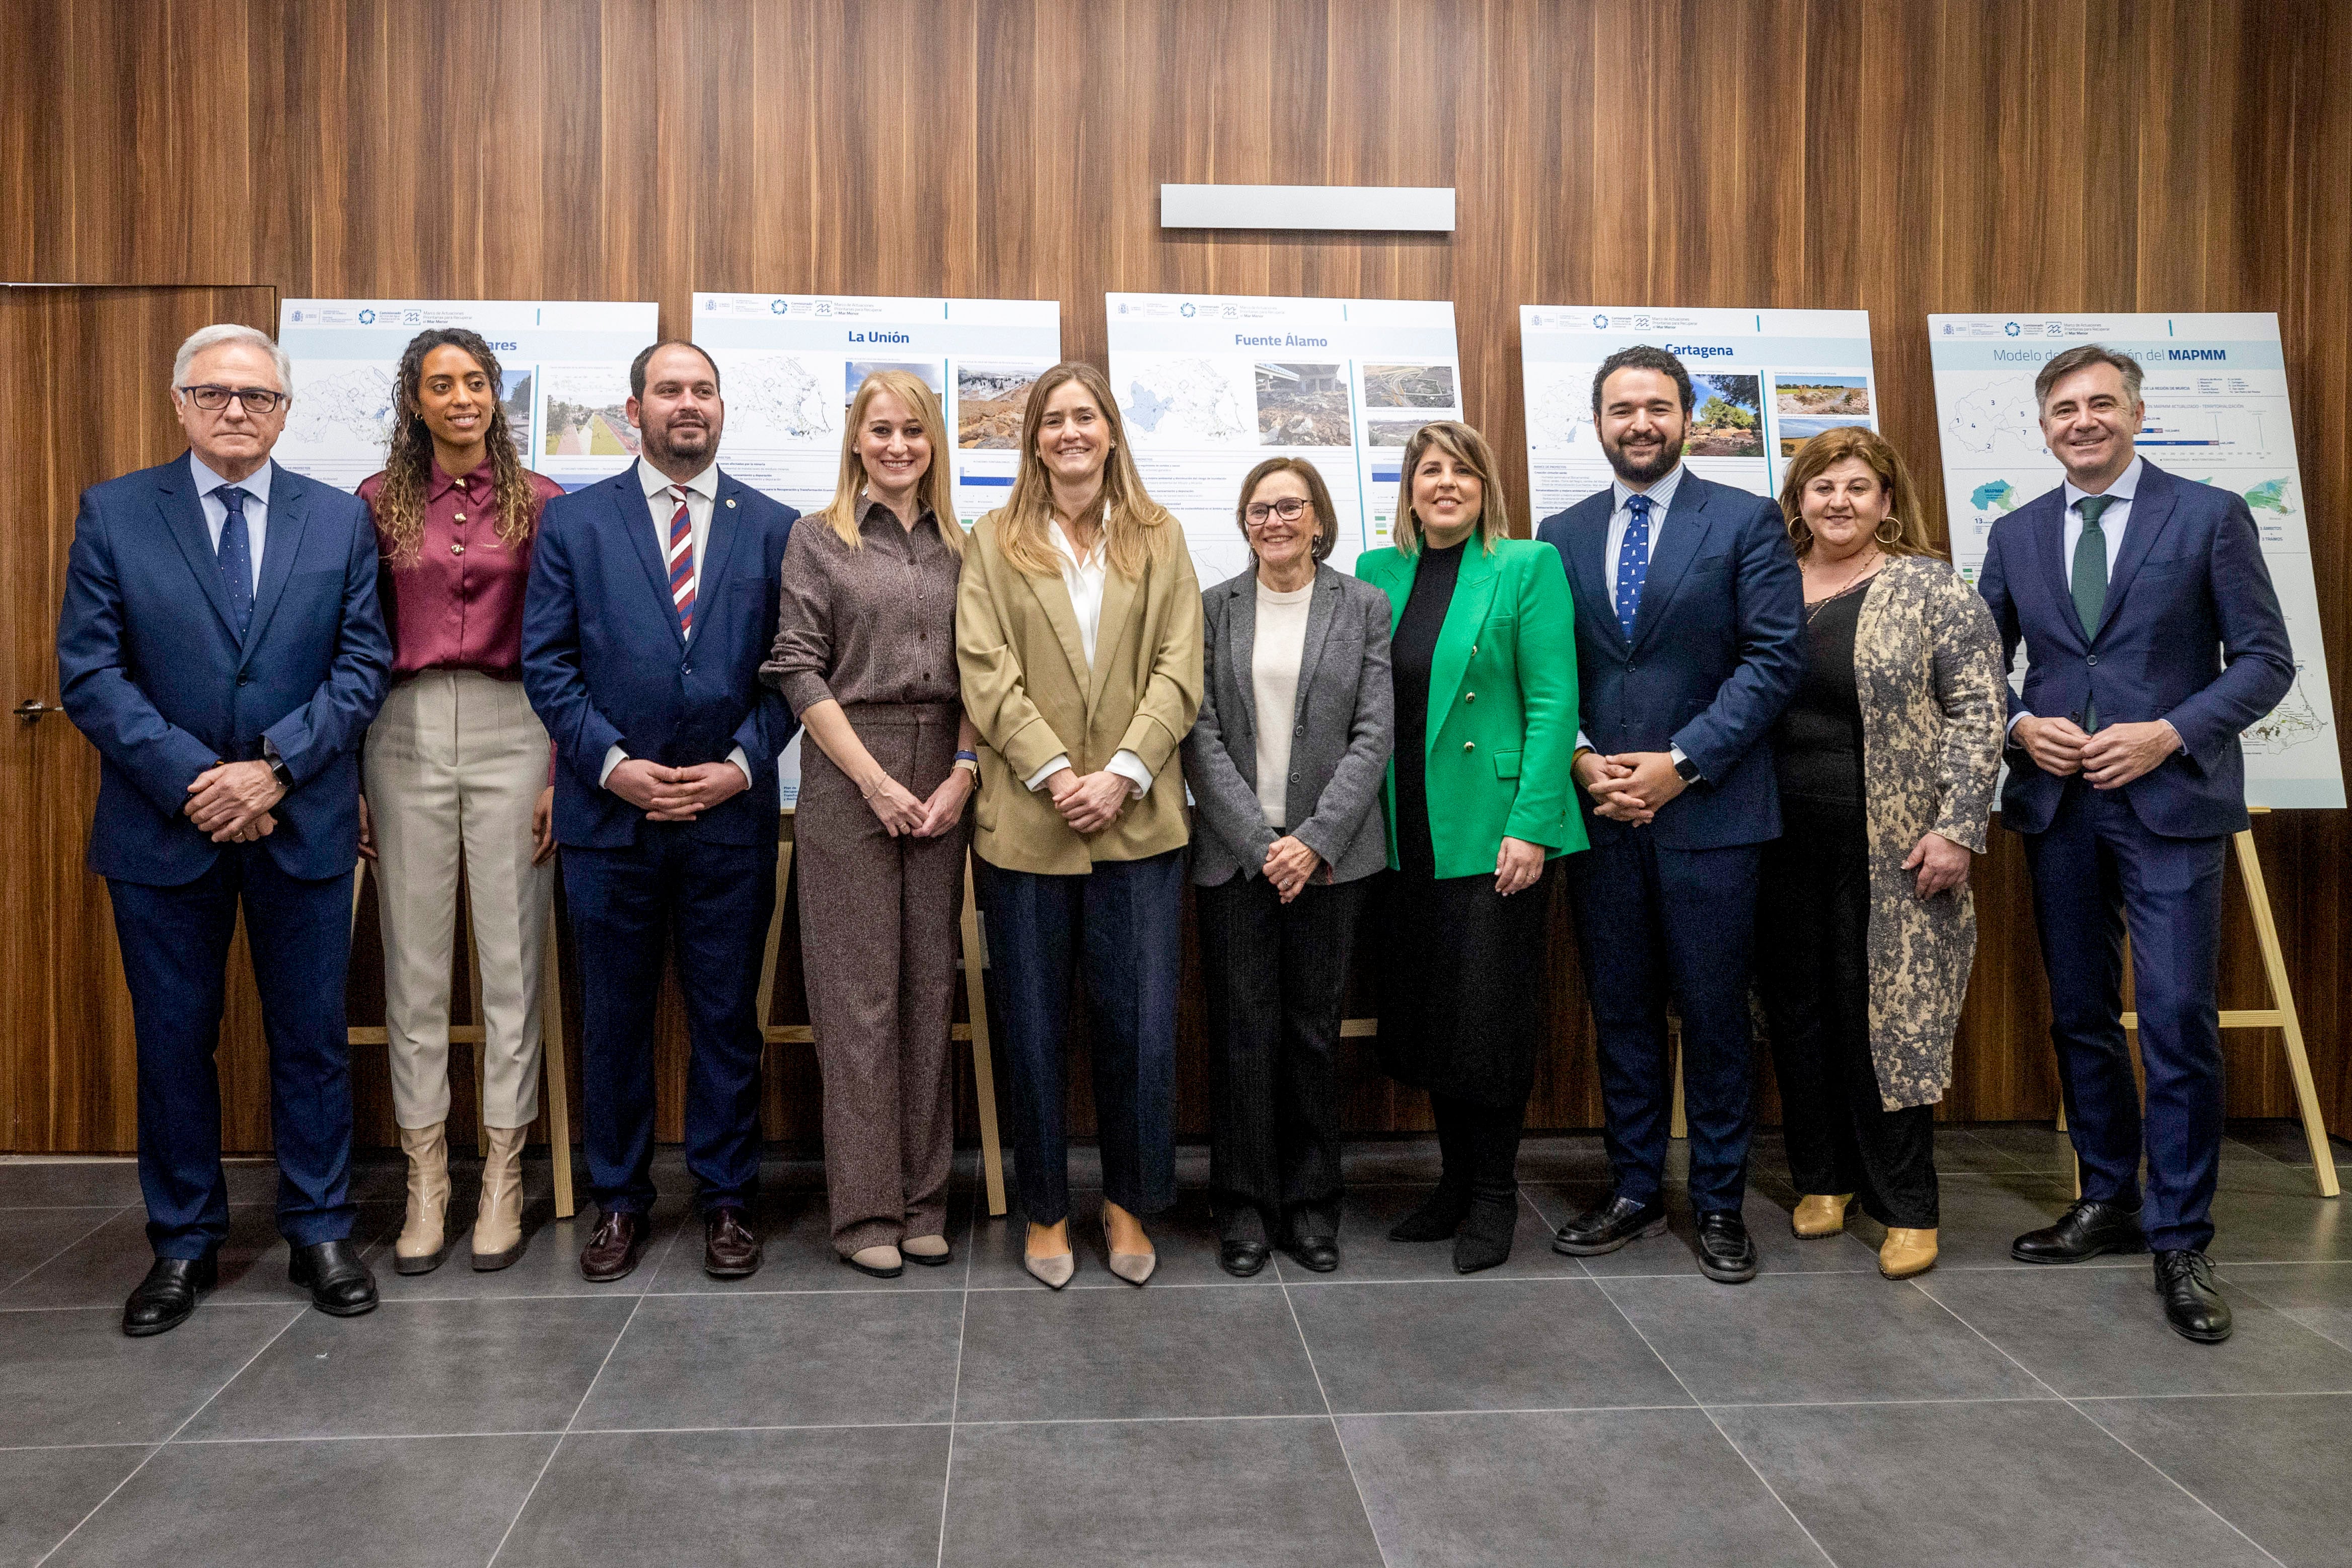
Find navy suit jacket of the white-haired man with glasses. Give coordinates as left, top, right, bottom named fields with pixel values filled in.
left=56, top=454, right=393, bottom=886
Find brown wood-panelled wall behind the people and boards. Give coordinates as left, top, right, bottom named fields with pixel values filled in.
left=0, top=0, right=2352, bottom=1152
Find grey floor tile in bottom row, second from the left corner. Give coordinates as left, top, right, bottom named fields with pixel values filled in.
left=49, top=1436, right=555, bottom=1568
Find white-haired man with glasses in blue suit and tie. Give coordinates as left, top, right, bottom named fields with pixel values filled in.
left=56, top=327, right=393, bottom=1335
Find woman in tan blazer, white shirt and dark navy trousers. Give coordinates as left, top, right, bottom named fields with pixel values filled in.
left=955, top=364, right=1202, bottom=1291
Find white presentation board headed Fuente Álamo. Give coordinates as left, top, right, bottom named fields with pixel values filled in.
left=1103, top=294, right=1463, bottom=588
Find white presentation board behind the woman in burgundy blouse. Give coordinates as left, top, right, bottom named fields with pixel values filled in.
left=275, top=298, right=661, bottom=489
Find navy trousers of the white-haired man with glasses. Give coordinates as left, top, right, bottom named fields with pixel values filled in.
left=106, top=844, right=357, bottom=1258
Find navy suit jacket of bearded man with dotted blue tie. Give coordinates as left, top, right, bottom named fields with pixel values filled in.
left=1536, top=470, right=1804, bottom=849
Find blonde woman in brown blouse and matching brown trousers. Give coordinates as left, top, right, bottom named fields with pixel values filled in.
left=760, top=369, right=979, bottom=1279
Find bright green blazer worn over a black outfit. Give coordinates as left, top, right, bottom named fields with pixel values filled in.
left=1355, top=538, right=1585, bottom=877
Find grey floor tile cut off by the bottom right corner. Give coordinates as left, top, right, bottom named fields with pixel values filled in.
left=2082, top=1394, right=2352, bottom=1568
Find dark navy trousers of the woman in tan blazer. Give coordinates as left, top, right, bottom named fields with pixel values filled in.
left=979, top=849, right=1183, bottom=1225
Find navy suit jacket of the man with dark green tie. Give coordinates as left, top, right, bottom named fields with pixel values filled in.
left=1975, top=463, right=2296, bottom=839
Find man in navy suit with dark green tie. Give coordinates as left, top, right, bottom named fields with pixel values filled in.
left=1978, top=343, right=2296, bottom=1345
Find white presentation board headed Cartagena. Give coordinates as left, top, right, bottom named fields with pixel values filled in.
left=1519, top=306, right=1879, bottom=522
